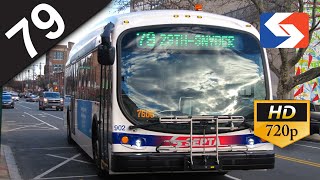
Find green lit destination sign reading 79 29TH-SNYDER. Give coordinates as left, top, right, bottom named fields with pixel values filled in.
left=136, top=32, right=236, bottom=50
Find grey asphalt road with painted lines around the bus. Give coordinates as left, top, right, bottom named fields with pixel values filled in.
left=1, top=99, right=320, bottom=180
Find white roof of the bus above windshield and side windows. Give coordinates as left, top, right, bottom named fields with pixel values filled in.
left=66, top=10, right=259, bottom=66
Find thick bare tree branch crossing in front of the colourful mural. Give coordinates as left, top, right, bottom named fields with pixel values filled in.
left=288, top=67, right=320, bottom=89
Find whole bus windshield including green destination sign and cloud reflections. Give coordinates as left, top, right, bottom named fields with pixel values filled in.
left=118, top=25, right=267, bottom=132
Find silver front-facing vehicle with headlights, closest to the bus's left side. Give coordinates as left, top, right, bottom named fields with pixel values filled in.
left=39, top=91, right=63, bottom=111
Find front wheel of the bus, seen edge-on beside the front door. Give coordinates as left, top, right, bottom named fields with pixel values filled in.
left=92, top=120, right=104, bottom=177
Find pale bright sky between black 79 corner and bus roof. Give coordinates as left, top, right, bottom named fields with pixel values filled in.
left=16, top=0, right=130, bottom=80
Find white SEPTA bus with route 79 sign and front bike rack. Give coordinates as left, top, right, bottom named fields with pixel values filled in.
left=64, top=10, right=275, bottom=174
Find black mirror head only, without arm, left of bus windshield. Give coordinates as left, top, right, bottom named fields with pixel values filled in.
left=98, top=44, right=115, bottom=65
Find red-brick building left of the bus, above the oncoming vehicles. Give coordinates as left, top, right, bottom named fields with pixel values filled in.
left=44, top=42, right=74, bottom=93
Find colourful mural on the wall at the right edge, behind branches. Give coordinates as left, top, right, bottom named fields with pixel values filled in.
left=294, top=2, right=320, bottom=104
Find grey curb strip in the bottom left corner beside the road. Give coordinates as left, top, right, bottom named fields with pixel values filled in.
left=1, top=144, right=22, bottom=180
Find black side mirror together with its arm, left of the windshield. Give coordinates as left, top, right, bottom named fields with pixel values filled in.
left=98, top=22, right=115, bottom=65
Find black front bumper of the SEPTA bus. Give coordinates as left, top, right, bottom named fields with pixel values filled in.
left=111, top=151, right=275, bottom=172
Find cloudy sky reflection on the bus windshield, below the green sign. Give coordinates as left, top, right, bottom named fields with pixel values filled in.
left=121, top=25, right=266, bottom=131
